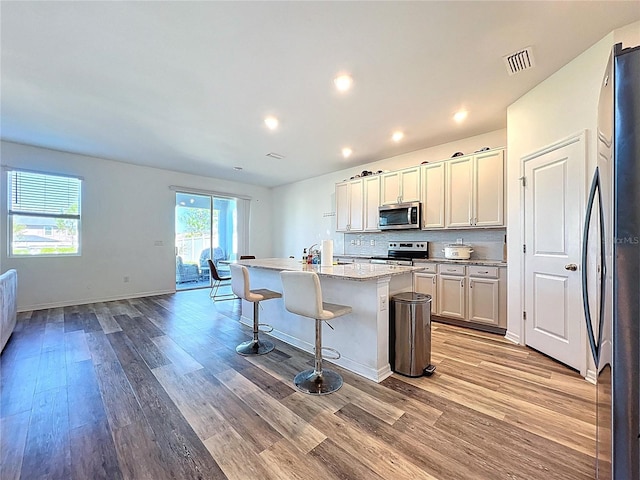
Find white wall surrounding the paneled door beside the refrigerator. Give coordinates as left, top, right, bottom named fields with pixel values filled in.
left=507, top=22, right=640, bottom=343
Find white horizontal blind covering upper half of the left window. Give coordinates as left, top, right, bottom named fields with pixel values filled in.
left=9, top=171, right=81, bottom=219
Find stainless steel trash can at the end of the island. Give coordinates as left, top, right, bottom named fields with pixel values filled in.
left=389, top=292, right=435, bottom=377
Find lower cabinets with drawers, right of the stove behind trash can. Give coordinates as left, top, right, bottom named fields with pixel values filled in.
left=414, top=263, right=507, bottom=331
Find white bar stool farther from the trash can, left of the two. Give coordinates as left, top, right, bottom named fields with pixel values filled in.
left=230, top=264, right=282, bottom=355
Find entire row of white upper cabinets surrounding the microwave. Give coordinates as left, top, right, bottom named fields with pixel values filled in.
left=336, top=148, right=505, bottom=232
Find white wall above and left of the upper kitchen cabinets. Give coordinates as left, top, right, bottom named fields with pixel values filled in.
left=273, top=130, right=507, bottom=258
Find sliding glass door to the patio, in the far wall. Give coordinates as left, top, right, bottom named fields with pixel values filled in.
left=175, top=192, right=238, bottom=289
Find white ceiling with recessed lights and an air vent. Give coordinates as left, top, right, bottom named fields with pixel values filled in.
left=0, top=0, right=640, bottom=186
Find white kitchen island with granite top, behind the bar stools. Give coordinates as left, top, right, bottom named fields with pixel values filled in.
left=238, top=258, right=422, bottom=382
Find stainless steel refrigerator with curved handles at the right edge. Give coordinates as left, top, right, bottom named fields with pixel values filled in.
left=582, top=44, right=640, bottom=480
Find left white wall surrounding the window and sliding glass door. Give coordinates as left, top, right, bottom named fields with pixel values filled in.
left=0, top=142, right=272, bottom=310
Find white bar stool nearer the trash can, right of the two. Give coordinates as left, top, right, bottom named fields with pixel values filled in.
left=280, top=271, right=351, bottom=395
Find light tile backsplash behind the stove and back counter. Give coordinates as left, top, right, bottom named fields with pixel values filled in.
left=342, top=228, right=507, bottom=261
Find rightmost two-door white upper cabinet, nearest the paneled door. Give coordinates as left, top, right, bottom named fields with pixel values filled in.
left=445, top=149, right=504, bottom=228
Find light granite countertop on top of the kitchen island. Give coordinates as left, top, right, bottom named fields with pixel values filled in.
left=238, top=258, right=422, bottom=281
